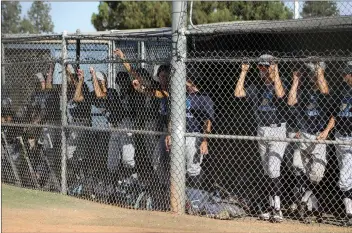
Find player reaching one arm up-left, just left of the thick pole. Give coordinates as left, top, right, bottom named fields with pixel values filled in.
left=115, top=49, right=170, bottom=185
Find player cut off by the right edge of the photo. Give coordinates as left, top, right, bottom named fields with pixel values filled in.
left=333, top=61, right=352, bottom=226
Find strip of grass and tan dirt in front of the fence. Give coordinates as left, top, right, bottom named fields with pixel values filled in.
left=2, top=184, right=352, bottom=232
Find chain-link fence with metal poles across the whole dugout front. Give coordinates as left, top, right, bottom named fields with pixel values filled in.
left=1, top=2, right=352, bottom=228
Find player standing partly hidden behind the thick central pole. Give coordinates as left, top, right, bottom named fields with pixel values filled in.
left=165, top=79, right=214, bottom=189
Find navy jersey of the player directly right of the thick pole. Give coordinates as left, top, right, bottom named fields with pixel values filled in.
left=186, top=93, right=214, bottom=133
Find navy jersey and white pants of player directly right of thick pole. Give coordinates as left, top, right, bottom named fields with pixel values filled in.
left=186, top=93, right=214, bottom=188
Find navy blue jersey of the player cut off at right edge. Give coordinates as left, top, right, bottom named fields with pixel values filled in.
left=332, top=84, right=352, bottom=133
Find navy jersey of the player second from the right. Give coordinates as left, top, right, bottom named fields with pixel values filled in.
left=297, top=84, right=331, bottom=134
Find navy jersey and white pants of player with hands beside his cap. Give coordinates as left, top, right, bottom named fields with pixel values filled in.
left=236, top=68, right=287, bottom=221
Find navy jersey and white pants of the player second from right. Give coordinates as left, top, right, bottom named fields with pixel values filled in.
left=296, top=82, right=331, bottom=220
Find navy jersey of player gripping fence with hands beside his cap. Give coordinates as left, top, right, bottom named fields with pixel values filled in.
left=246, top=82, right=287, bottom=126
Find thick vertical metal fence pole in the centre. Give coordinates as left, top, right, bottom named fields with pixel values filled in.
left=170, top=1, right=187, bottom=214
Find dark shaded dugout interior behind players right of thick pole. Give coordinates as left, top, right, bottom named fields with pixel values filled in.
left=187, top=25, right=352, bottom=217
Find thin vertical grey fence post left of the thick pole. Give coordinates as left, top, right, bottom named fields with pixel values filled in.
left=61, top=31, right=67, bottom=195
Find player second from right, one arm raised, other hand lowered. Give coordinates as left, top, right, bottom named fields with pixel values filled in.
left=288, top=59, right=333, bottom=221
